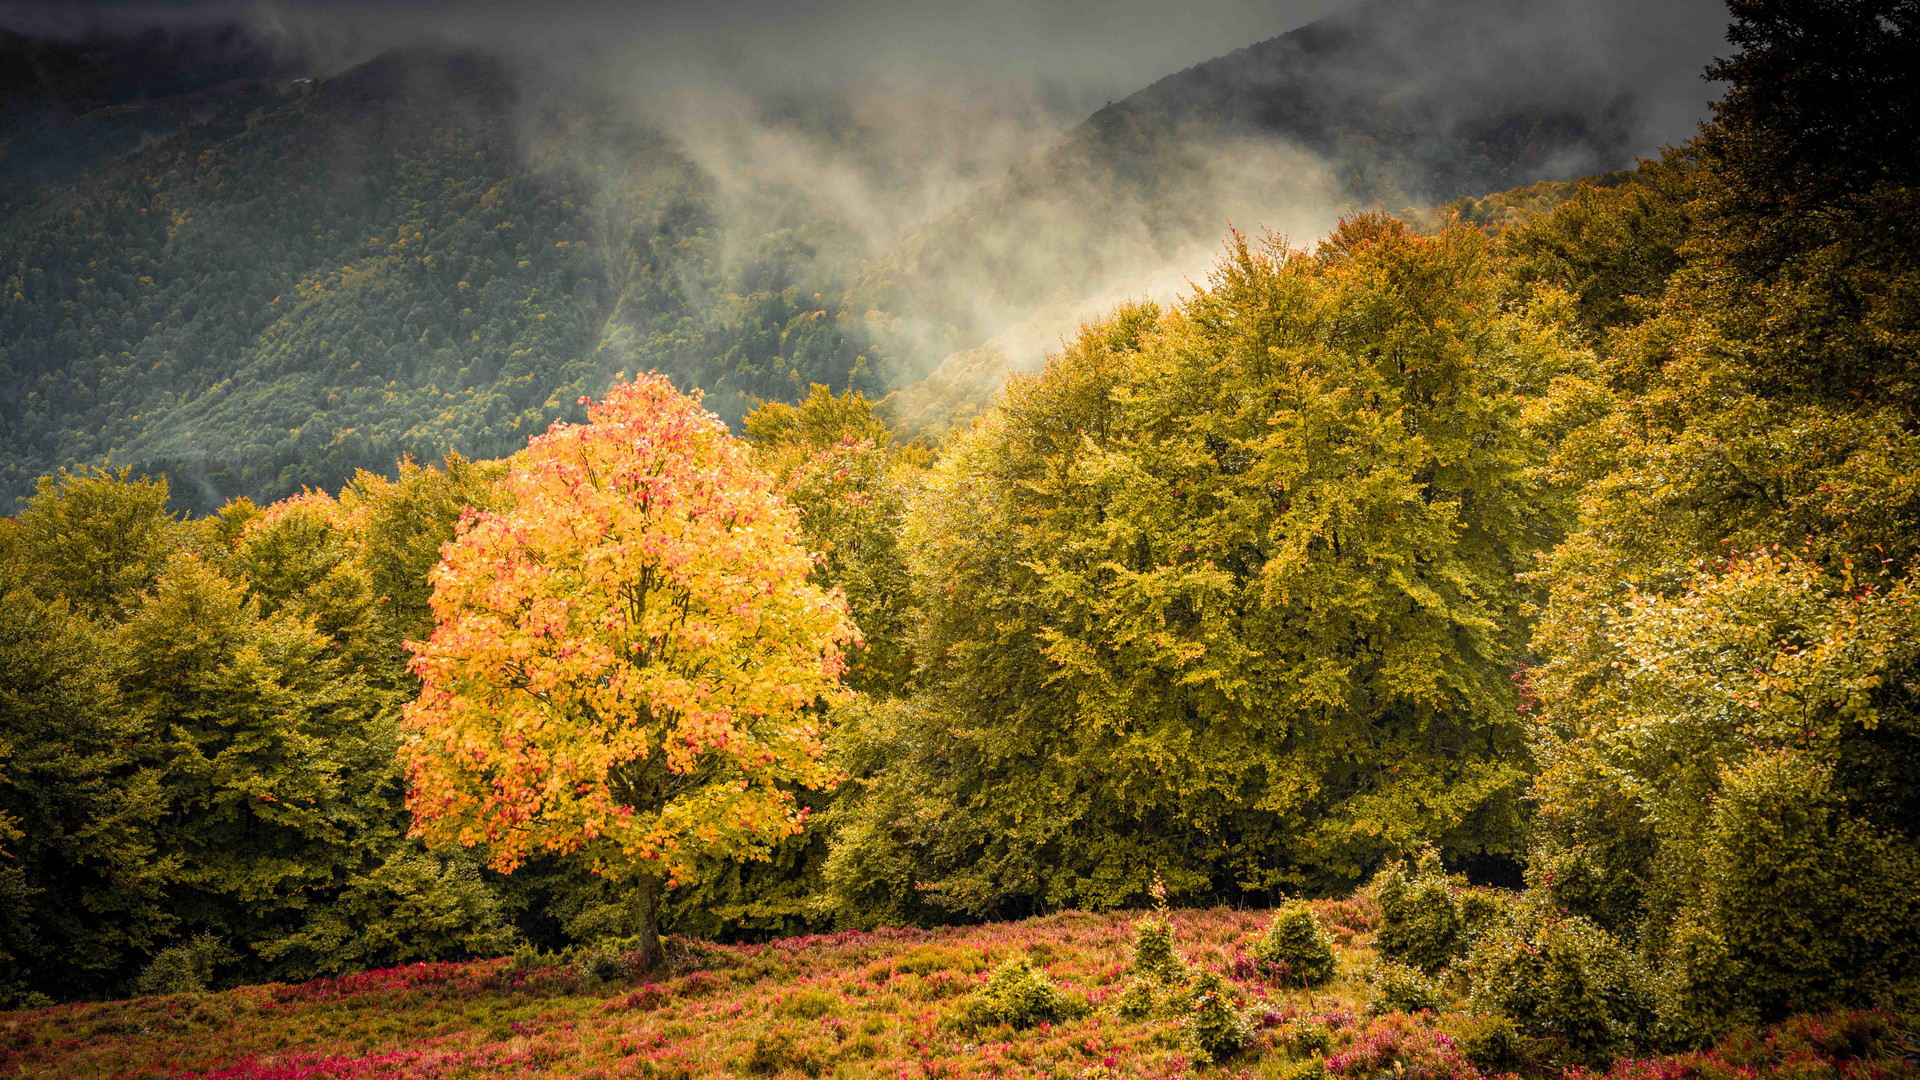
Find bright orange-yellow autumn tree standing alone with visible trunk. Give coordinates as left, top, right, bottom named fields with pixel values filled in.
left=405, top=375, right=858, bottom=963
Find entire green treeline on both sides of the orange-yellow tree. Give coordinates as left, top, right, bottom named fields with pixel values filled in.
left=0, top=4, right=1920, bottom=1047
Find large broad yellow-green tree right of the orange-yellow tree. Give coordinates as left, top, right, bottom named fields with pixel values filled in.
left=829, top=217, right=1574, bottom=915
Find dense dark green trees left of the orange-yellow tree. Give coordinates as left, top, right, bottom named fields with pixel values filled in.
left=0, top=459, right=511, bottom=995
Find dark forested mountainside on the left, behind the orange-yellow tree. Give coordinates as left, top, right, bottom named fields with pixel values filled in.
left=0, top=50, right=872, bottom=509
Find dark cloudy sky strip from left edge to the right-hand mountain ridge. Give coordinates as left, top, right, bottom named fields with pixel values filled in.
left=0, top=0, right=1342, bottom=106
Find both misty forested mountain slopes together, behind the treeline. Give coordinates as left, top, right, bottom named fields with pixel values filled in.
left=0, top=0, right=1728, bottom=513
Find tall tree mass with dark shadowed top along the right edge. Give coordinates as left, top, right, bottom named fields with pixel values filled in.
left=1530, top=0, right=1920, bottom=999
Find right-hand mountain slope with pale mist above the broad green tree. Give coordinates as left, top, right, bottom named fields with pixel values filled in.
left=866, top=0, right=1724, bottom=438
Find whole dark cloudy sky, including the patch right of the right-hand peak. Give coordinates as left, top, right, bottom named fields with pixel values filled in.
left=0, top=0, right=1726, bottom=146
